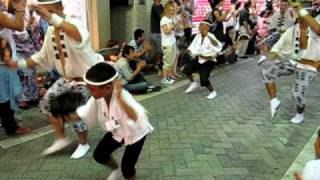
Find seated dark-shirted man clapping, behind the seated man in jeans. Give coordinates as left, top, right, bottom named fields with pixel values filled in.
left=128, top=29, right=152, bottom=70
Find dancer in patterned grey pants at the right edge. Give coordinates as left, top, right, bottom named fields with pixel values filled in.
left=262, top=2, right=320, bottom=123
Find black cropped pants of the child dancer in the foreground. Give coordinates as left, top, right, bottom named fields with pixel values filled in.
left=93, top=132, right=146, bottom=178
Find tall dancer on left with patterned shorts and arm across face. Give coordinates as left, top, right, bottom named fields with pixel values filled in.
left=8, top=0, right=103, bottom=159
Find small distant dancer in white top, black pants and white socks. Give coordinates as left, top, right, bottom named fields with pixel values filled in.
left=182, top=20, right=222, bottom=99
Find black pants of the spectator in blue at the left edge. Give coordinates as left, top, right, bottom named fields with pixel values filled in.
left=0, top=101, right=19, bottom=135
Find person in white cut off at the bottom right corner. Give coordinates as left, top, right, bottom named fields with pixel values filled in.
left=294, top=129, right=320, bottom=180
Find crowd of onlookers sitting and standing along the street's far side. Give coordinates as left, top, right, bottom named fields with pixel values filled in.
left=102, top=0, right=284, bottom=93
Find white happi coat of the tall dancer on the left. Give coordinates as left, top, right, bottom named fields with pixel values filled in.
left=31, top=16, right=103, bottom=78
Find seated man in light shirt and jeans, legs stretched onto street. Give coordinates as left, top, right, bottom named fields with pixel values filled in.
left=114, top=45, right=161, bottom=94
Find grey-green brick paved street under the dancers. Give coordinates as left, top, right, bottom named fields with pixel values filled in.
left=0, top=59, right=320, bottom=180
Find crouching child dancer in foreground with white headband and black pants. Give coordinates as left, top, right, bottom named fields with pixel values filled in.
left=74, top=63, right=153, bottom=180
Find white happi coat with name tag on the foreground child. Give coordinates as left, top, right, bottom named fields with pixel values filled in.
left=77, top=89, right=153, bottom=145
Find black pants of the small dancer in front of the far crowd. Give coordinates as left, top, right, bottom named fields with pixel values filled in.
left=182, top=59, right=215, bottom=86
